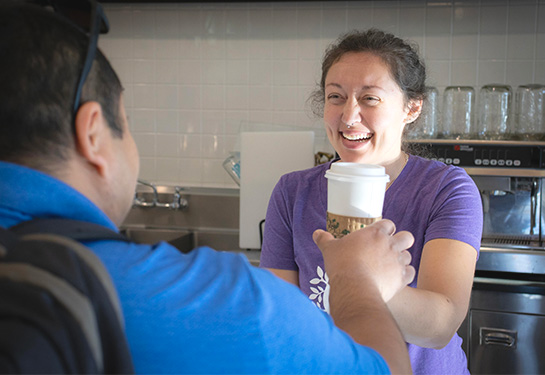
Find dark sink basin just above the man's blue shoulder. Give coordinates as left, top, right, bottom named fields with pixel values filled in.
left=120, top=228, right=195, bottom=253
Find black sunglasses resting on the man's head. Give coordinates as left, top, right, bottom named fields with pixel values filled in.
left=30, top=0, right=110, bottom=118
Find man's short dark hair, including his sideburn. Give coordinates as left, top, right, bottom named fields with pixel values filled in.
left=0, top=3, right=123, bottom=171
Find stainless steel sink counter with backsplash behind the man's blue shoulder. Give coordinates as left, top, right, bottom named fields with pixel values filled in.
left=120, top=185, right=261, bottom=265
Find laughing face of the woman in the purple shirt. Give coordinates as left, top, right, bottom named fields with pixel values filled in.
left=324, top=52, right=416, bottom=164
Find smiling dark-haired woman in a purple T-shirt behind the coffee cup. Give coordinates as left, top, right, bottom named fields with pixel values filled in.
left=261, top=29, right=482, bottom=374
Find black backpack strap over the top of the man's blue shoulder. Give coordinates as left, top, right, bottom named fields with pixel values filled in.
left=10, top=218, right=130, bottom=242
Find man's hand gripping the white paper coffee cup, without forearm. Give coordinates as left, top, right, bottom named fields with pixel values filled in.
left=313, top=220, right=415, bottom=302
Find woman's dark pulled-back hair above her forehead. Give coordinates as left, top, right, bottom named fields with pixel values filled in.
left=309, top=28, right=426, bottom=116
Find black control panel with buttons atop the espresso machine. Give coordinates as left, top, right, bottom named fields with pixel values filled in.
left=409, top=140, right=545, bottom=169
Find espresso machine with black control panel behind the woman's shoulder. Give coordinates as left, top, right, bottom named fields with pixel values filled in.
left=411, top=140, right=545, bottom=249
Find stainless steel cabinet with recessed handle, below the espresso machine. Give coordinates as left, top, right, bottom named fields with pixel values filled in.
left=459, top=280, right=545, bottom=375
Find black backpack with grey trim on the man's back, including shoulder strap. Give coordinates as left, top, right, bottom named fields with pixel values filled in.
left=0, top=219, right=134, bottom=374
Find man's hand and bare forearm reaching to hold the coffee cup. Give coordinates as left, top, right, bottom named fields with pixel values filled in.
left=313, top=220, right=415, bottom=374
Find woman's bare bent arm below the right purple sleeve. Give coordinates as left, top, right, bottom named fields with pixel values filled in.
left=388, top=239, right=477, bottom=349
